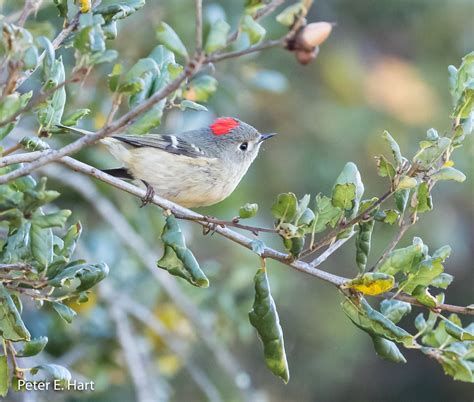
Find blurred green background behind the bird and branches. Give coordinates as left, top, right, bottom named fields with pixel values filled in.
left=5, top=0, right=474, bottom=401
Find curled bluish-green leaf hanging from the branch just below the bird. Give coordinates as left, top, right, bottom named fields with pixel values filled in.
left=157, top=215, right=209, bottom=288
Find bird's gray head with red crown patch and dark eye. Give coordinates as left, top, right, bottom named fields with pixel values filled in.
left=185, top=117, right=274, bottom=167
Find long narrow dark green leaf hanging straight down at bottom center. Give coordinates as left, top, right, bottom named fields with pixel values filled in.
left=249, top=268, right=290, bottom=384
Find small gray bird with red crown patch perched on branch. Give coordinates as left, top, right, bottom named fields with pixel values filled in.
left=60, top=117, right=274, bottom=207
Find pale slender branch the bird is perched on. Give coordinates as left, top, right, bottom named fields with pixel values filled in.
left=44, top=157, right=474, bottom=315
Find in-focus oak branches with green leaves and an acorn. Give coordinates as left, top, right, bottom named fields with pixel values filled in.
left=0, top=0, right=474, bottom=395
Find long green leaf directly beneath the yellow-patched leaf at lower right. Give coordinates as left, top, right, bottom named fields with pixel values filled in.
left=342, top=297, right=413, bottom=347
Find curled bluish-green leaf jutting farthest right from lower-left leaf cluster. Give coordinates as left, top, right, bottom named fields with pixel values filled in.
left=48, top=262, right=109, bottom=292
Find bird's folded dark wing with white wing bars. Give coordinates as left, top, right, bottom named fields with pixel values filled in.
left=112, top=134, right=205, bottom=158
